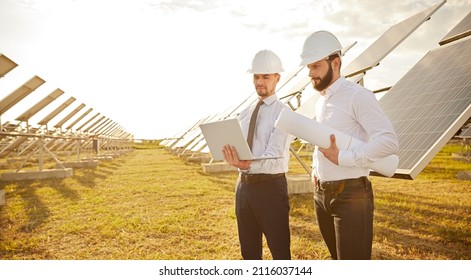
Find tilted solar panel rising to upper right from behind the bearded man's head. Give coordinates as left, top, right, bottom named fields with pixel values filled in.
left=342, top=1, right=446, bottom=77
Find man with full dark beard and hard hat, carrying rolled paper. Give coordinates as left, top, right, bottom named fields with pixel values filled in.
left=300, top=31, right=399, bottom=259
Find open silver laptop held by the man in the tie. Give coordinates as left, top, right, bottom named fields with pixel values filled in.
left=200, top=119, right=280, bottom=160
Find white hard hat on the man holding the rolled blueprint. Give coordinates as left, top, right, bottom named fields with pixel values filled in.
left=299, top=30, right=342, bottom=66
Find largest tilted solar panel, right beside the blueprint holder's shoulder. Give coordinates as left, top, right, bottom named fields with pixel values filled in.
left=379, top=37, right=471, bottom=179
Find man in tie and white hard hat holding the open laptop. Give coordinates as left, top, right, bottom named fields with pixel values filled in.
left=223, top=50, right=292, bottom=260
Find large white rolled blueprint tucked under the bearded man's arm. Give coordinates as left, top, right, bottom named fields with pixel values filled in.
left=275, top=109, right=399, bottom=177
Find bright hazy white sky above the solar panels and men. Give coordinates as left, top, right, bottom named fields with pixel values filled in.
left=0, top=0, right=471, bottom=139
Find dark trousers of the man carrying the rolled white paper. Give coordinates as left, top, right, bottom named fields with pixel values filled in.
left=314, top=177, right=374, bottom=260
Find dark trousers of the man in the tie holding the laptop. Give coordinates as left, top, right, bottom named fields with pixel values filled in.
left=236, top=176, right=291, bottom=260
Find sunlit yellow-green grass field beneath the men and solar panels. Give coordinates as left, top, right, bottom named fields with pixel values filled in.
left=0, top=144, right=471, bottom=260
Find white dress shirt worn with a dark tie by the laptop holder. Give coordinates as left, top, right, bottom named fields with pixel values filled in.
left=239, top=94, right=293, bottom=174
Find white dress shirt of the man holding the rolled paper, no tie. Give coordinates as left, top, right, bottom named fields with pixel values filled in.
left=313, top=77, right=399, bottom=181
